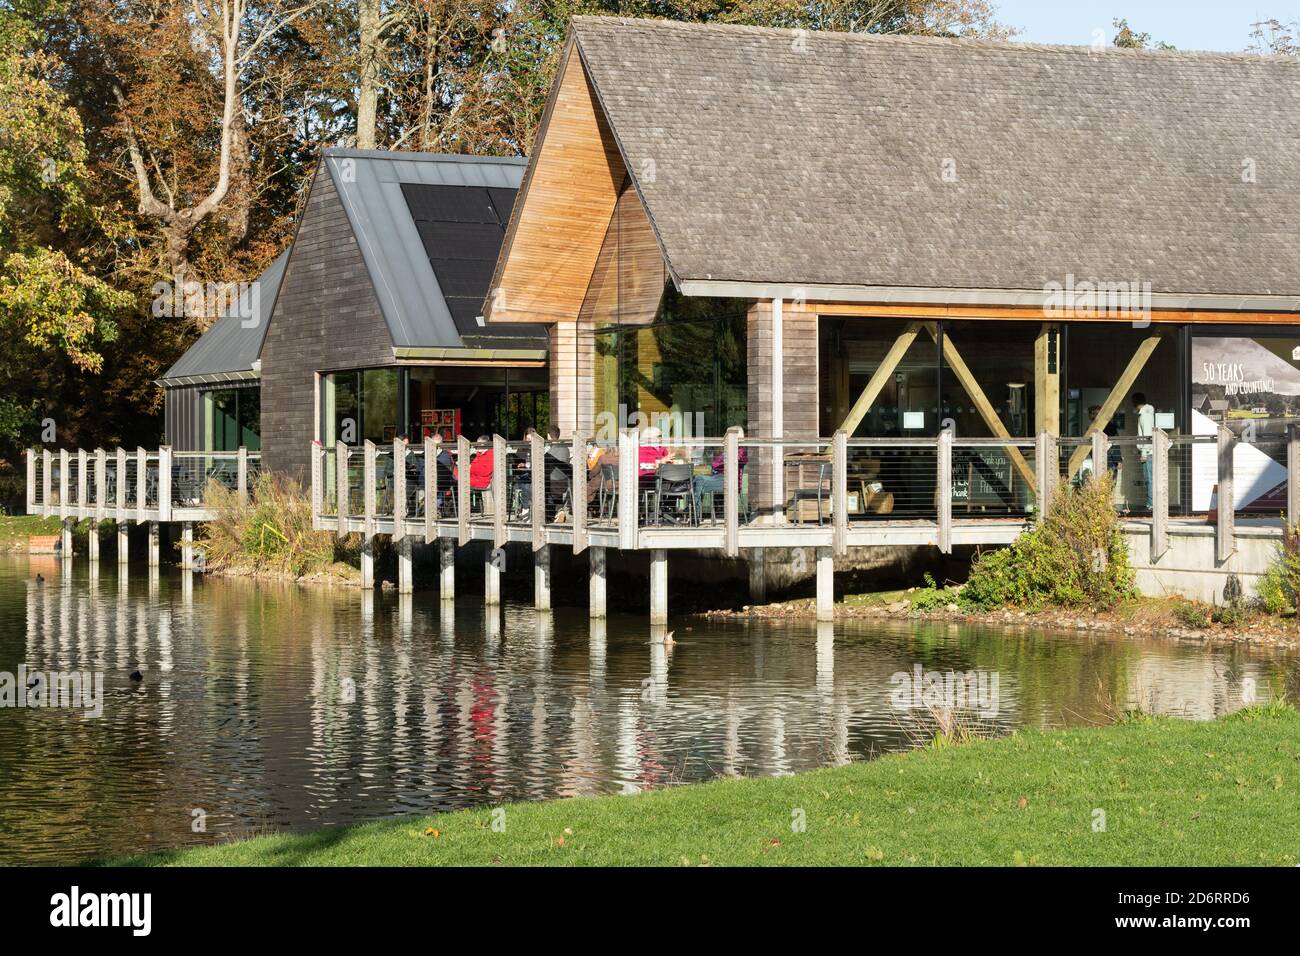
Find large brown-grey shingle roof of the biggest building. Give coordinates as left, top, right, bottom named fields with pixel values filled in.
left=573, top=17, right=1300, bottom=303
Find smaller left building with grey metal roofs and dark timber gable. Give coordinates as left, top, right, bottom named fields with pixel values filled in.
left=160, top=150, right=549, bottom=476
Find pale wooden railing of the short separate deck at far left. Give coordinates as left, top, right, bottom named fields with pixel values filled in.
left=27, top=446, right=261, bottom=524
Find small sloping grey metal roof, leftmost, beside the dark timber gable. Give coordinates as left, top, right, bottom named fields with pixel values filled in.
left=159, top=251, right=289, bottom=385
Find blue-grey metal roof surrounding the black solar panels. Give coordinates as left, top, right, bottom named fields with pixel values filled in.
left=324, top=150, right=546, bottom=349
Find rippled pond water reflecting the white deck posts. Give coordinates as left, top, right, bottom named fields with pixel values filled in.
left=0, top=557, right=1297, bottom=864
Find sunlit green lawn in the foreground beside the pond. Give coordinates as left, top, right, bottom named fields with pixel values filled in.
left=120, top=706, right=1300, bottom=866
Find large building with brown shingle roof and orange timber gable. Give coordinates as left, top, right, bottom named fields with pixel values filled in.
left=484, top=17, right=1300, bottom=511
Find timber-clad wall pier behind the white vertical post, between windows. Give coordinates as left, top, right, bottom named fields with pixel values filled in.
left=746, top=302, right=818, bottom=511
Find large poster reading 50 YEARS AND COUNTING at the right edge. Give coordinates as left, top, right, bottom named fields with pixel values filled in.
left=1192, top=336, right=1300, bottom=512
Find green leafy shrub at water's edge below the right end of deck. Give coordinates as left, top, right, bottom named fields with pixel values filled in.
left=961, top=475, right=1134, bottom=610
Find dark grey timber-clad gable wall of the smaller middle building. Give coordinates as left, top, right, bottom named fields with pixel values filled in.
left=261, top=169, right=394, bottom=480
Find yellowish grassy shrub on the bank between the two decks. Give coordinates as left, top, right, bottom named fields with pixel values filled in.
left=200, top=473, right=351, bottom=575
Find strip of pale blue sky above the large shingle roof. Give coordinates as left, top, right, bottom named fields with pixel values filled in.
left=993, top=0, right=1300, bottom=51
